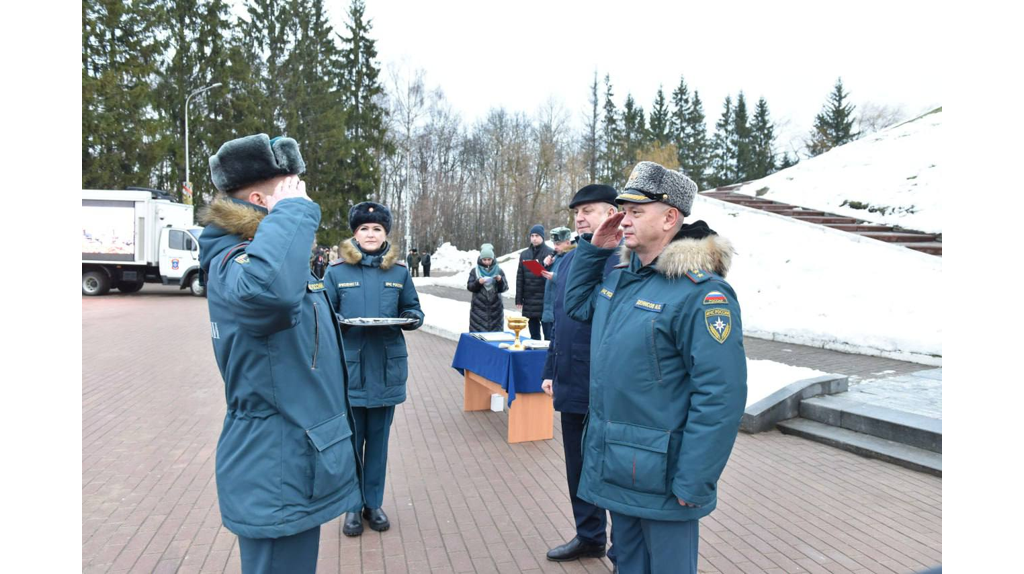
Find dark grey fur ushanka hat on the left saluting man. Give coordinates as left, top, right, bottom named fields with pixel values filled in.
left=210, top=134, right=306, bottom=193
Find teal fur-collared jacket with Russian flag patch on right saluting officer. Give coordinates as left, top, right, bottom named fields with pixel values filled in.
left=565, top=222, right=746, bottom=521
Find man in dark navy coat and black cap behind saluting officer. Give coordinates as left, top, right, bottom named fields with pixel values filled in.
left=542, top=184, right=618, bottom=564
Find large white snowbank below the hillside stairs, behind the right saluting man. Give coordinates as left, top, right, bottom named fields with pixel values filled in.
left=692, top=195, right=948, bottom=364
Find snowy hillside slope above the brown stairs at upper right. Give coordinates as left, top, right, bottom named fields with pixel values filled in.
left=736, top=108, right=943, bottom=233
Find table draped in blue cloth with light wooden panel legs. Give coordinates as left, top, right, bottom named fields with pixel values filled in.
left=452, top=333, right=555, bottom=443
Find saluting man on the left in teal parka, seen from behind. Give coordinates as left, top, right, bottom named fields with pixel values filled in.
left=200, top=134, right=362, bottom=574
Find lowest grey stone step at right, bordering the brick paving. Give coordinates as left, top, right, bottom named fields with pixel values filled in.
left=776, top=418, right=942, bottom=477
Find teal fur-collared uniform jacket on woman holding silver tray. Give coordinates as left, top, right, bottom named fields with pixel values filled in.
left=324, top=239, right=423, bottom=408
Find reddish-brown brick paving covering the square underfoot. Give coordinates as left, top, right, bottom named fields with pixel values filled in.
left=82, top=285, right=942, bottom=574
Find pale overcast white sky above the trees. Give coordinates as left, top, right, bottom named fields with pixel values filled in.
left=329, top=0, right=942, bottom=148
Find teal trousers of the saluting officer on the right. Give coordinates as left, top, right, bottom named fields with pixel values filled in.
left=611, top=513, right=698, bottom=574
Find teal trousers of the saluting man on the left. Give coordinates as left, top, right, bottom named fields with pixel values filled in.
left=239, top=526, right=319, bottom=574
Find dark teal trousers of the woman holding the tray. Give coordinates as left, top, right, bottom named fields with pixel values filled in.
left=352, top=406, right=394, bottom=509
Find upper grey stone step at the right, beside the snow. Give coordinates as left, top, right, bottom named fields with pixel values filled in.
left=800, top=393, right=942, bottom=454
